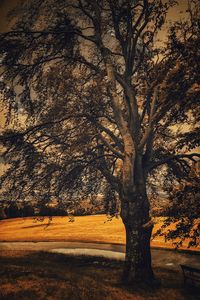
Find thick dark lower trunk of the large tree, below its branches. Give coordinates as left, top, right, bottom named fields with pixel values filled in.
left=121, top=190, right=155, bottom=285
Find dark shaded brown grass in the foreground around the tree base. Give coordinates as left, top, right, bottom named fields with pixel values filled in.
left=0, top=251, right=198, bottom=300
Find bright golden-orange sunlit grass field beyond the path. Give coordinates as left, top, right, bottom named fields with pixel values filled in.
left=0, top=215, right=200, bottom=251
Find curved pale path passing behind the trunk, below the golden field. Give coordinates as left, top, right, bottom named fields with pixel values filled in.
left=0, top=242, right=200, bottom=270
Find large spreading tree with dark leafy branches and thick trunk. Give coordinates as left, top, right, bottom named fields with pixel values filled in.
left=0, top=0, right=200, bottom=283
